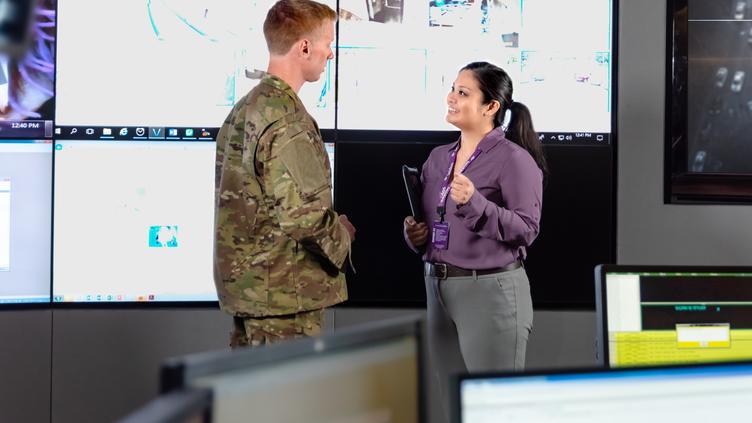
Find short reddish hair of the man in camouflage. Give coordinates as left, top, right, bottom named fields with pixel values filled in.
left=264, top=0, right=337, bottom=55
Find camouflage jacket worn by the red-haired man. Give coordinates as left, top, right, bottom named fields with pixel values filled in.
left=214, top=74, right=350, bottom=317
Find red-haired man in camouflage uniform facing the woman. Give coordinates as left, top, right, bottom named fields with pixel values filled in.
left=214, top=0, right=355, bottom=348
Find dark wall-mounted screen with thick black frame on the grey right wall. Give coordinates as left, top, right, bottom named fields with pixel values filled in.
left=664, top=0, right=752, bottom=203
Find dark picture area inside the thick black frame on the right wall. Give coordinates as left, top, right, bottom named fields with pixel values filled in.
left=687, top=0, right=752, bottom=174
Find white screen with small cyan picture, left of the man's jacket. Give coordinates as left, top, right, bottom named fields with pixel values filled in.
left=53, top=141, right=216, bottom=301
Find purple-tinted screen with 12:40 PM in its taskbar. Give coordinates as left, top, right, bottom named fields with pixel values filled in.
left=0, top=0, right=55, bottom=139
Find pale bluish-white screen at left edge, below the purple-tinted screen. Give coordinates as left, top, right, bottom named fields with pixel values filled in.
left=0, top=141, right=52, bottom=303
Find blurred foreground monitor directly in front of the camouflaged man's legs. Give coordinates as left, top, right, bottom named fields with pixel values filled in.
left=162, top=318, right=422, bottom=423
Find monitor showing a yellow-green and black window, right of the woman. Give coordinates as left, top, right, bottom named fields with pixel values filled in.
left=595, top=265, right=752, bottom=367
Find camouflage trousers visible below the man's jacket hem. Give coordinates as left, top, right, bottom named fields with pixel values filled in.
left=230, top=310, right=324, bottom=348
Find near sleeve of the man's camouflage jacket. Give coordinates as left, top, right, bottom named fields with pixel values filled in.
left=264, top=123, right=351, bottom=269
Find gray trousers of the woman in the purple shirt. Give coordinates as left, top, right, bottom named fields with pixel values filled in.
left=425, top=267, right=533, bottom=420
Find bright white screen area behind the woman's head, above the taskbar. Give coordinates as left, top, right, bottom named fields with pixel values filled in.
left=337, top=0, right=613, bottom=133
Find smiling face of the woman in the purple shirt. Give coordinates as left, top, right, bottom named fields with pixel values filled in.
left=446, top=70, right=493, bottom=130
